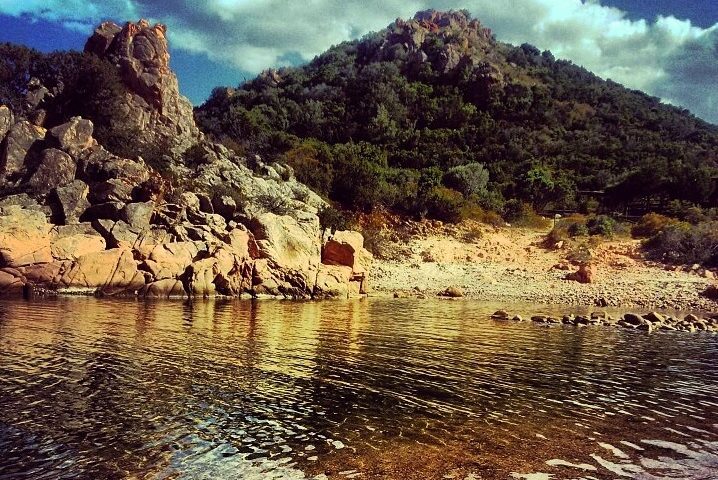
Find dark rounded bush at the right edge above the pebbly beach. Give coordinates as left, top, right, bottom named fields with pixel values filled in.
left=645, top=222, right=718, bottom=266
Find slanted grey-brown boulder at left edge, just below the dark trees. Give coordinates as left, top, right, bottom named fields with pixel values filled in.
left=0, top=120, right=47, bottom=181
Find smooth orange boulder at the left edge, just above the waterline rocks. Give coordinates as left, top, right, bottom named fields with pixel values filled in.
left=0, top=206, right=53, bottom=267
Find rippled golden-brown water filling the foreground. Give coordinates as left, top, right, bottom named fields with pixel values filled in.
left=0, top=298, right=718, bottom=480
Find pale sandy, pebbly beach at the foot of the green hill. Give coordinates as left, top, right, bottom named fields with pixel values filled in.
left=369, top=225, right=718, bottom=313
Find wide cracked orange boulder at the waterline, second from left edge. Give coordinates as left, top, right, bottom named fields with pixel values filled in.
left=59, top=248, right=145, bottom=295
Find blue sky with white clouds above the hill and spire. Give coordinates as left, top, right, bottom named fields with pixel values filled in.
left=0, top=0, right=718, bottom=124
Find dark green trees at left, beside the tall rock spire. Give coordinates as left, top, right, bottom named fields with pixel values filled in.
left=0, top=43, right=136, bottom=156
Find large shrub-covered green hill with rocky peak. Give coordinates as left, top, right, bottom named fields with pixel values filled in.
left=196, top=10, right=718, bottom=220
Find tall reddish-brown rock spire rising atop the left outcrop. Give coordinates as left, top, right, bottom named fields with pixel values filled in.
left=85, top=20, right=201, bottom=153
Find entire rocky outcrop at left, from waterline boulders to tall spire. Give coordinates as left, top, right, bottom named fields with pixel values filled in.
left=0, top=21, right=372, bottom=298
